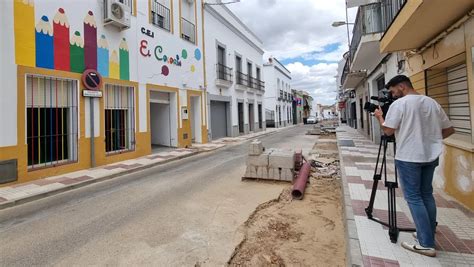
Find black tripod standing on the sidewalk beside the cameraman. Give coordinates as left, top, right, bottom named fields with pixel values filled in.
left=365, top=135, right=416, bottom=243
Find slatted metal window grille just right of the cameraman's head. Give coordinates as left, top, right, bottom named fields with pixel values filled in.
left=426, top=63, right=472, bottom=137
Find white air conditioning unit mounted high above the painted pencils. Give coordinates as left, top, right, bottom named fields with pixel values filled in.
left=104, top=0, right=131, bottom=30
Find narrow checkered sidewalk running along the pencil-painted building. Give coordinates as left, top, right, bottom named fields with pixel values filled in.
left=0, top=126, right=294, bottom=210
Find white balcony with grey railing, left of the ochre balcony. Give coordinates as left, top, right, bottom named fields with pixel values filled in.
left=350, top=3, right=385, bottom=70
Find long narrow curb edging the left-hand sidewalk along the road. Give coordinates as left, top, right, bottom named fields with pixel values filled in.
left=0, top=126, right=293, bottom=210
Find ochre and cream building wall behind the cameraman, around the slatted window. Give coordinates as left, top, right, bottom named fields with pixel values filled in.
left=407, top=17, right=474, bottom=209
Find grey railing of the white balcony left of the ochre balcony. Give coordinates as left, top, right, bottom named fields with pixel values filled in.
left=351, top=3, right=384, bottom=59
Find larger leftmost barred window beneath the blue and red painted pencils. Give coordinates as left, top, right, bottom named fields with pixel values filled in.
left=26, top=75, right=78, bottom=169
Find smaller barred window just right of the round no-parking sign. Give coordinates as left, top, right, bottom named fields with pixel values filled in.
left=104, top=84, right=135, bottom=154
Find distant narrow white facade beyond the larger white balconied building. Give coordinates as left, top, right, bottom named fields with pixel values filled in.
left=263, top=57, right=293, bottom=128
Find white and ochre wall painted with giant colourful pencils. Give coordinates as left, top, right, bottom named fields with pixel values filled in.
left=0, top=0, right=207, bottom=185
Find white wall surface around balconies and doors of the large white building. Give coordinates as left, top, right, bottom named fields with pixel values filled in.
left=204, top=5, right=267, bottom=138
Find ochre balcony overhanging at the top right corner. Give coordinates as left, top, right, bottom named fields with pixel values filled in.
left=380, top=0, right=474, bottom=53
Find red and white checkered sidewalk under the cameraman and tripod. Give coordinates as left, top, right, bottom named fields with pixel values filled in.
left=337, top=126, right=474, bottom=266
